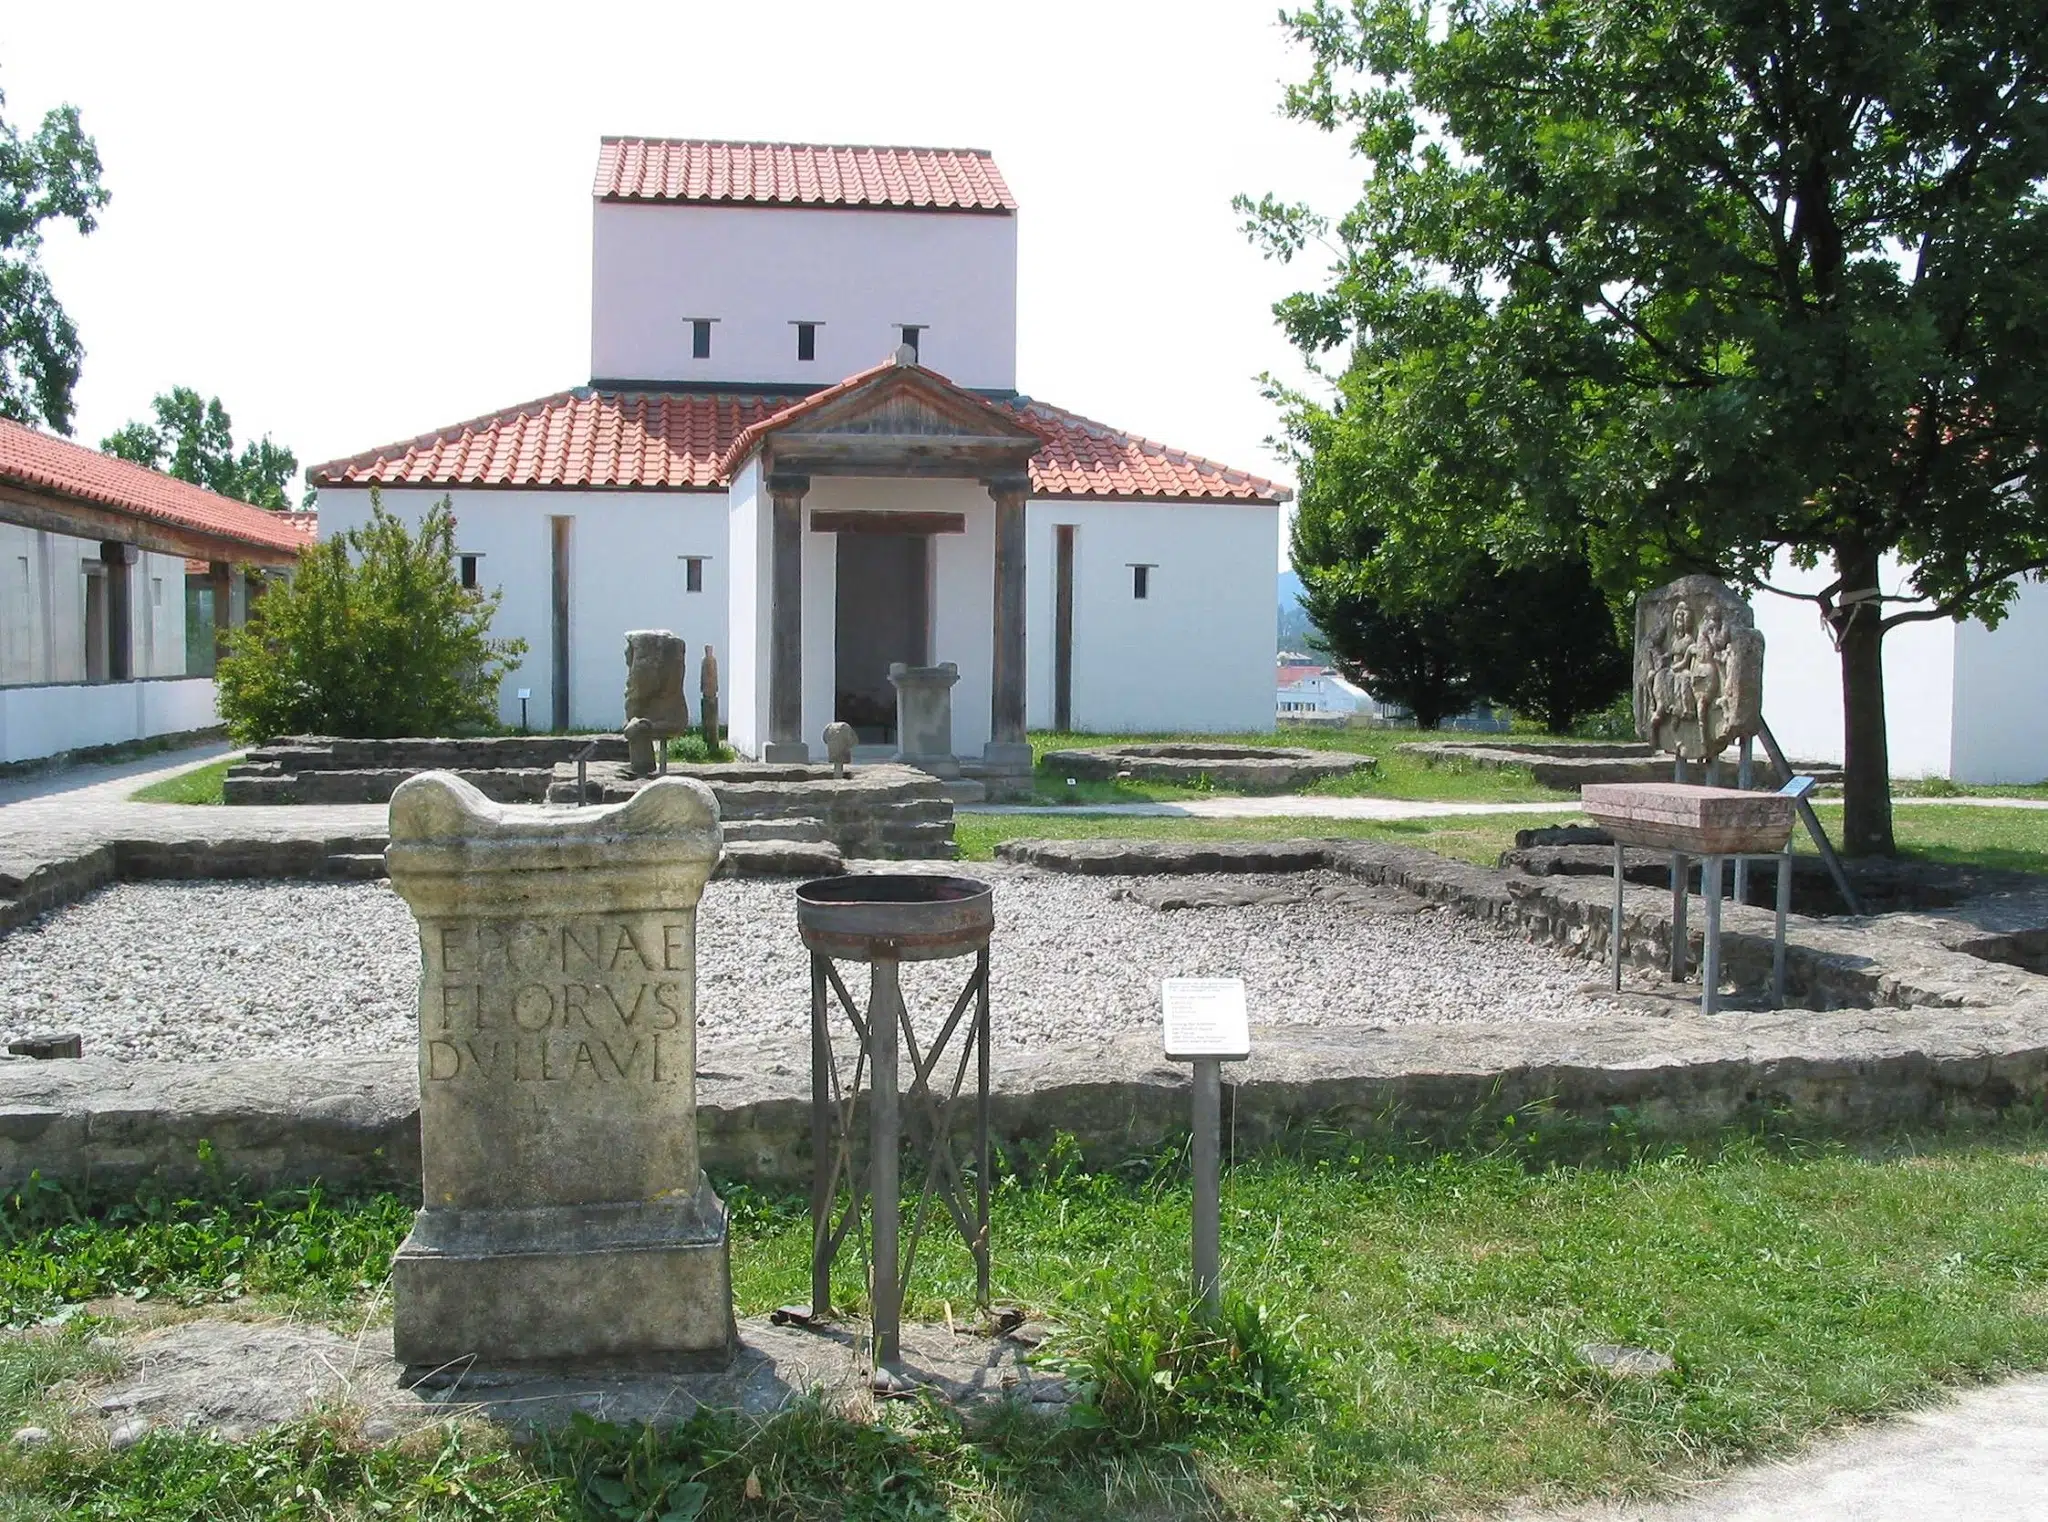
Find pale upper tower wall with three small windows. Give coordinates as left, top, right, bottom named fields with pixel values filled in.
left=590, top=201, right=1018, bottom=389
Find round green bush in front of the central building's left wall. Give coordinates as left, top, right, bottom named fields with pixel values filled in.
left=215, top=488, right=526, bottom=744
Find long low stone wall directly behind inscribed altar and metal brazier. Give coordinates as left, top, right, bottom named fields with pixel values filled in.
left=0, top=998, right=2048, bottom=1188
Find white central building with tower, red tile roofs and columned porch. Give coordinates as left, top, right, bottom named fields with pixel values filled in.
left=309, top=139, right=1288, bottom=770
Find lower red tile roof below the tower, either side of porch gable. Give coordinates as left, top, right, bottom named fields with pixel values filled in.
left=309, top=377, right=1290, bottom=502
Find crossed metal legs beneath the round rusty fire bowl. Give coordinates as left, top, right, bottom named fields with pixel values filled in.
left=811, top=946, right=989, bottom=1368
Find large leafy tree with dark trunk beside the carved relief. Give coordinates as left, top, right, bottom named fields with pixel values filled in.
left=1247, top=0, right=2048, bottom=854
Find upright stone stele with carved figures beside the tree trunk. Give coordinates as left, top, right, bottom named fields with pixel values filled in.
left=1634, top=576, right=1763, bottom=762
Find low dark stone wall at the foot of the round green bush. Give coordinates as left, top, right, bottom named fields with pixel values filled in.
left=221, top=735, right=627, bottom=803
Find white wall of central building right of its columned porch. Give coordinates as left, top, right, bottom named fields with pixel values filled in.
left=1024, top=500, right=1278, bottom=733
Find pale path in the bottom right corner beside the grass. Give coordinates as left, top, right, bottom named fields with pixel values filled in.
left=1524, top=1377, right=2048, bottom=1522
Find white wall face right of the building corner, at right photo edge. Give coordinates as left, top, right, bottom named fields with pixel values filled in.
left=1941, top=582, right=2048, bottom=783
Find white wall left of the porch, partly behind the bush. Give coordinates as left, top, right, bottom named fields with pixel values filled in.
left=319, top=488, right=729, bottom=729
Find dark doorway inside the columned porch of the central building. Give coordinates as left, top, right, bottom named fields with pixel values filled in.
left=831, top=533, right=932, bottom=746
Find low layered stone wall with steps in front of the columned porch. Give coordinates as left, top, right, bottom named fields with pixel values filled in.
left=547, top=762, right=958, bottom=860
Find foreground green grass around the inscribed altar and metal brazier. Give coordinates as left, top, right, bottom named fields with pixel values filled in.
left=0, top=1116, right=2048, bottom=1520
